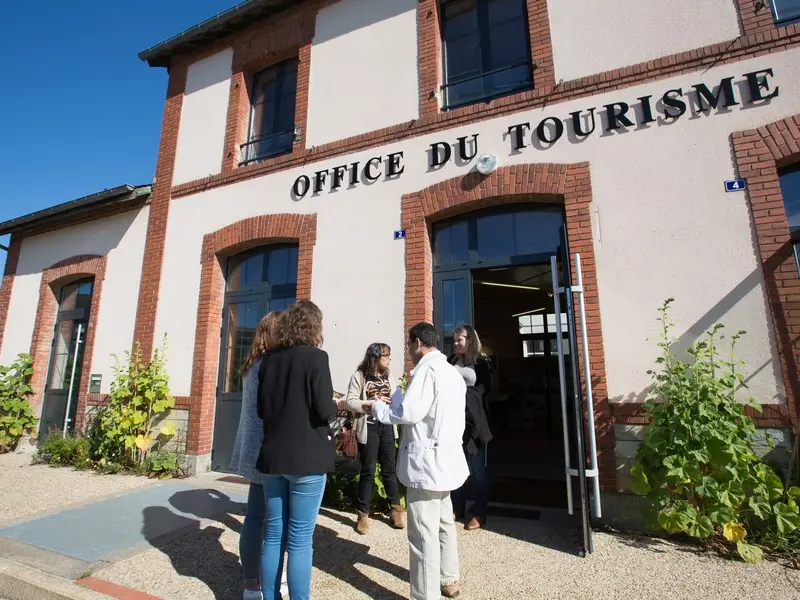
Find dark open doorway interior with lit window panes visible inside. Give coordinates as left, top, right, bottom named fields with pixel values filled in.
left=472, top=262, right=569, bottom=508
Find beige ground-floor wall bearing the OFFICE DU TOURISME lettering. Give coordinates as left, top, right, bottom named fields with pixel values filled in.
left=156, top=50, right=800, bottom=402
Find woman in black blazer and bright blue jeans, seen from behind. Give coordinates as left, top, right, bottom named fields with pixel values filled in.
left=256, top=300, right=336, bottom=600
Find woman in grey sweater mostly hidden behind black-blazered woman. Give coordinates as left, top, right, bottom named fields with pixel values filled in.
left=231, top=312, right=280, bottom=600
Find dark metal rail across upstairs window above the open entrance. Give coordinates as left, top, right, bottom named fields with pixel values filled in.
left=441, top=60, right=533, bottom=109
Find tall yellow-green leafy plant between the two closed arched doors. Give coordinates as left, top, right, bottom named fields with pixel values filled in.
left=95, top=338, right=175, bottom=469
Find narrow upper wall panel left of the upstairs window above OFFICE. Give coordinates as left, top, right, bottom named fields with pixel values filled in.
left=172, top=48, right=233, bottom=185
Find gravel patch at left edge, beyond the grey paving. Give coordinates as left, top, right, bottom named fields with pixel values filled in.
left=0, top=446, right=152, bottom=526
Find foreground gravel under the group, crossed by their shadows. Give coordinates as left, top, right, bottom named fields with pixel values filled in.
left=95, top=509, right=800, bottom=600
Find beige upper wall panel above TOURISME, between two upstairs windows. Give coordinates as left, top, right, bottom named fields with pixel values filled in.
left=547, top=0, right=740, bottom=81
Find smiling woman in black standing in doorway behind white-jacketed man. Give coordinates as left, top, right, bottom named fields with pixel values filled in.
left=450, top=325, right=492, bottom=531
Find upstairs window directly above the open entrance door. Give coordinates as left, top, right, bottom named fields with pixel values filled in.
left=441, top=0, right=533, bottom=108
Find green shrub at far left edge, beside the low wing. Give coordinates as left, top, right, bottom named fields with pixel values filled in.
left=0, top=354, right=39, bottom=454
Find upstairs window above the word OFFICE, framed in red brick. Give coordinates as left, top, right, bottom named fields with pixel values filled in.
left=240, top=59, right=297, bottom=164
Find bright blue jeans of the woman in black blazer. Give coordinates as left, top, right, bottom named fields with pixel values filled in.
left=261, top=475, right=326, bottom=600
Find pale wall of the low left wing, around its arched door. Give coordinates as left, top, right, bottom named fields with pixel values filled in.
left=0, top=207, right=149, bottom=393
